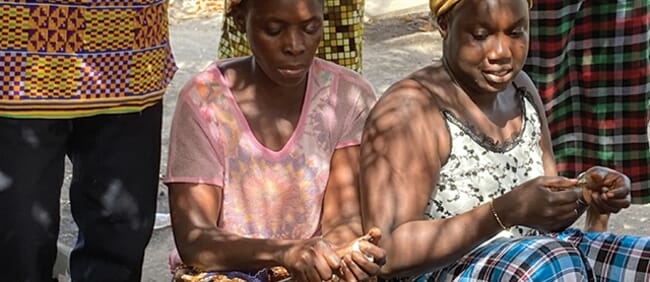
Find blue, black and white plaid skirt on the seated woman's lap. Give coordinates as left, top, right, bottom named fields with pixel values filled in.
left=415, top=229, right=650, bottom=282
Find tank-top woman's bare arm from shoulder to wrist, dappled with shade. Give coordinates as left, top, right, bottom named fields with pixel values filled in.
left=361, top=81, right=500, bottom=277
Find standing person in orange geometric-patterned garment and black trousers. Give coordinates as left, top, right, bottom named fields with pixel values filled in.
left=0, top=0, right=176, bottom=281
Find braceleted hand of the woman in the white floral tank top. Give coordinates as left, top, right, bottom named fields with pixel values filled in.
left=494, top=176, right=582, bottom=232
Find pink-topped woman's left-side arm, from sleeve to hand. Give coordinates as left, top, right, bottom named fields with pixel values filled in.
left=169, top=183, right=340, bottom=281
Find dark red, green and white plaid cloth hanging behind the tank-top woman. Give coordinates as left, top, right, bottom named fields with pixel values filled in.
left=524, top=0, right=650, bottom=204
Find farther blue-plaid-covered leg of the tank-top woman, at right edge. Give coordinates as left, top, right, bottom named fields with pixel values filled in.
left=556, top=229, right=650, bottom=281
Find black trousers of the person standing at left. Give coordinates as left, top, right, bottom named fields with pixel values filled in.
left=0, top=102, right=162, bottom=281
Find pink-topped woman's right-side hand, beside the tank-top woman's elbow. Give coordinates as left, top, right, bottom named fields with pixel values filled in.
left=336, top=228, right=386, bottom=282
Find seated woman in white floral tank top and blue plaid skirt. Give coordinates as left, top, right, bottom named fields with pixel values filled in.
left=361, top=0, right=650, bottom=281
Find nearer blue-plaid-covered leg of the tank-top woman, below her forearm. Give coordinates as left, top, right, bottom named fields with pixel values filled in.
left=418, top=236, right=593, bottom=281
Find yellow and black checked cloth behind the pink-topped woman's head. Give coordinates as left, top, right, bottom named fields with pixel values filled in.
left=219, top=0, right=365, bottom=72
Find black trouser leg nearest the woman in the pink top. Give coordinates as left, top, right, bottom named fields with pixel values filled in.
left=68, top=102, right=162, bottom=281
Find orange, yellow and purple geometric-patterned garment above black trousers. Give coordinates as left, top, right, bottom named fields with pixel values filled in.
left=0, top=0, right=176, bottom=118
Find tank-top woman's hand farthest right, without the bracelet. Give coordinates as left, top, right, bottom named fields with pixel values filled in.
left=578, top=166, right=631, bottom=214
